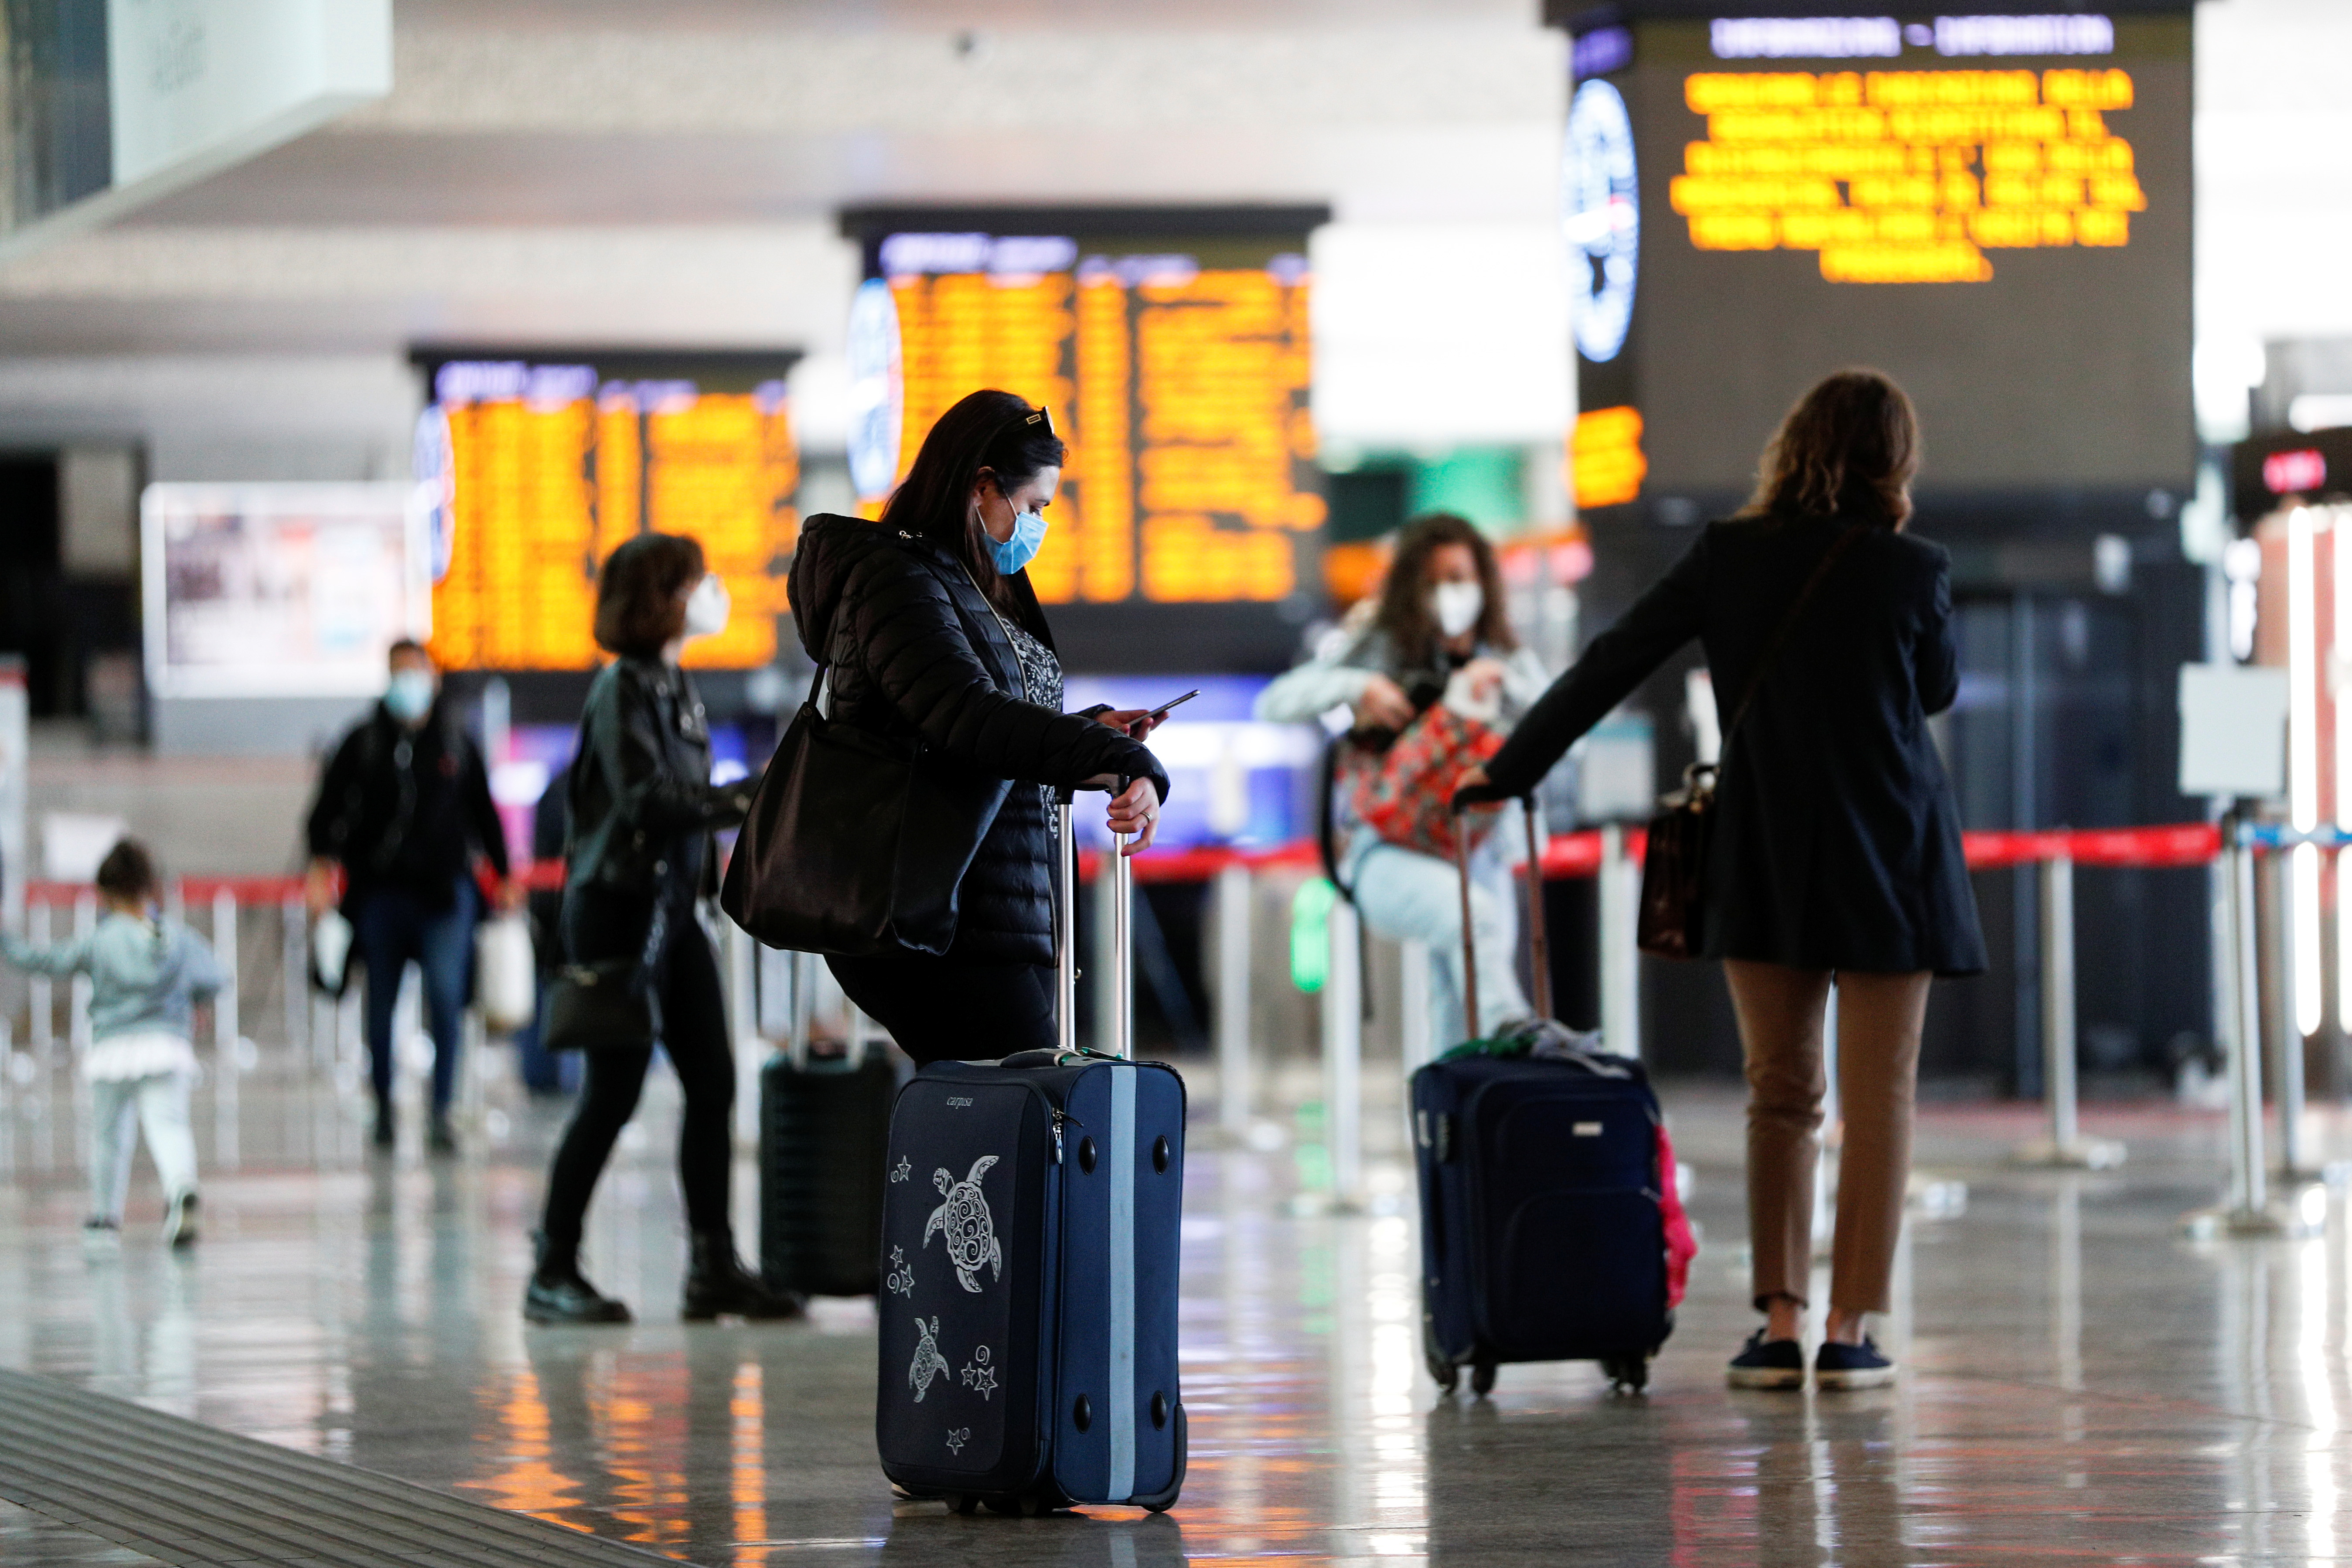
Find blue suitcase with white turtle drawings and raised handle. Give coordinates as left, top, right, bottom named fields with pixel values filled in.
left=875, top=804, right=1186, bottom=1514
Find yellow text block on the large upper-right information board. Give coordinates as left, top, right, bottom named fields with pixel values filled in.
left=1670, top=68, right=2147, bottom=282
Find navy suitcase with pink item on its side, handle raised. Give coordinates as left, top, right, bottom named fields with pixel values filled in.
left=1411, top=799, right=1689, bottom=1394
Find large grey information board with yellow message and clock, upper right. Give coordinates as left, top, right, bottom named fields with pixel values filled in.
left=1562, top=5, right=2195, bottom=522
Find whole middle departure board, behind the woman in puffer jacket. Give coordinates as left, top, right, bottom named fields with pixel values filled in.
left=844, top=209, right=1326, bottom=670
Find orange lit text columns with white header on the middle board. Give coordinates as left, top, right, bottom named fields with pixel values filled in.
left=882, top=251, right=1324, bottom=604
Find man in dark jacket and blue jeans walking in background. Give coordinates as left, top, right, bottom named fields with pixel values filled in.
left=310, top=639, right=518, bottom=1154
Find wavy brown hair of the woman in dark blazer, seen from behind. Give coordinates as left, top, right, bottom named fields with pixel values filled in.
left=1741, top=369, right=1919, bottom=529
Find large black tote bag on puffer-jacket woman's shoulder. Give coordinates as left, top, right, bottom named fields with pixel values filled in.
left=720, top=670, right=1011, bottom=957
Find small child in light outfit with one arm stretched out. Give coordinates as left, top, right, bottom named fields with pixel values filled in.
left=0, top=839, right=223, bottom=1251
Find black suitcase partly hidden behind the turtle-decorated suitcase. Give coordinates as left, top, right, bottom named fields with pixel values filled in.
left=760, top=1044, right=906, bottom=1295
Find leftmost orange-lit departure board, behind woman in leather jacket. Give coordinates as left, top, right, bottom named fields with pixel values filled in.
left=416, top=350, right=800, bottom=670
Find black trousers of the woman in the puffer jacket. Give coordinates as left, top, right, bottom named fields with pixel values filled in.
left=825, top=950, right=1054, bottom=1065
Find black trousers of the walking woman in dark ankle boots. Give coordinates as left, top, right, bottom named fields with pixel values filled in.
left=539, top=889, right=734, bottom=1258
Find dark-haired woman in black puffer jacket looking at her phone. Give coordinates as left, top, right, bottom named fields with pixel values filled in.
left=790, top=392, right=1166, bottom=1063
